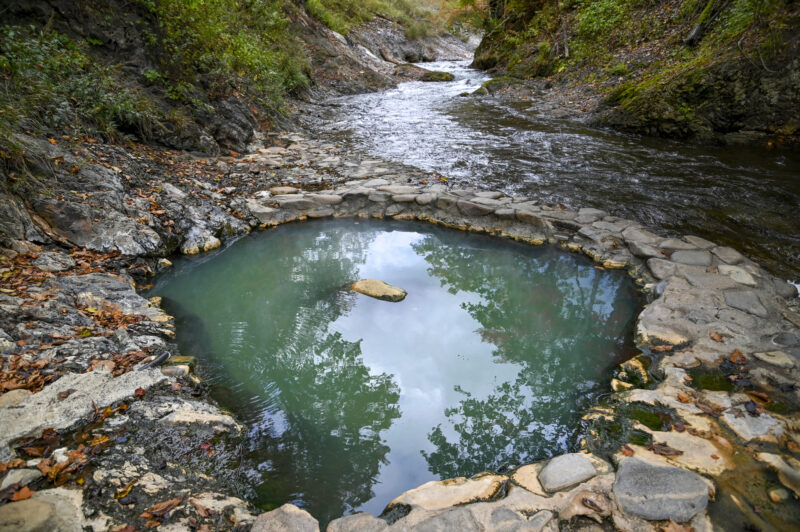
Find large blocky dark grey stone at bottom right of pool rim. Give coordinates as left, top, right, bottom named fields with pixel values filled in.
left=613, top=458, right=708, bottom=522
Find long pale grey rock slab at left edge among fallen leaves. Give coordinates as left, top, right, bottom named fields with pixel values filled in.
left=0, top=369, right=167, bottom=461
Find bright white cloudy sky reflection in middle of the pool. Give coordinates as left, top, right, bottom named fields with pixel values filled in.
left=330, top=231, right=536, bottom=513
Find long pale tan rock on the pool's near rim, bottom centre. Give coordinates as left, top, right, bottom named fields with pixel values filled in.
left=388, top=475, right=506, bottom=510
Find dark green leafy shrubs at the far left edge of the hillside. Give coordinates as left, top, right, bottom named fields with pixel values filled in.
left=0, top=26, right=157, bottom=143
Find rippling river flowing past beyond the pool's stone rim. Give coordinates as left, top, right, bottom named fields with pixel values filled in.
left=313, top=62, right=800, bottom=281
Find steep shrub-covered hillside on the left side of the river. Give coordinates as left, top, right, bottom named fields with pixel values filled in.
left=0, top=0, right=469, bottom=160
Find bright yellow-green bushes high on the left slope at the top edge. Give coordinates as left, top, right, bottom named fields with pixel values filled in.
left=138, top=0, right=308, bottom=107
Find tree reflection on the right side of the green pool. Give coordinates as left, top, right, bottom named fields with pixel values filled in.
left=414, top=236, right=636, bottom=478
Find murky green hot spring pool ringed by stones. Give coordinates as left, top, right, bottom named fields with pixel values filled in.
left=151, top=219, right=640, bottom=526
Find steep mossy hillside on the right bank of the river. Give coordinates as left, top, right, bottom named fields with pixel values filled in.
left=466, top=0, right=800, bottom=143
